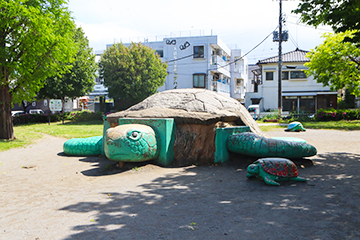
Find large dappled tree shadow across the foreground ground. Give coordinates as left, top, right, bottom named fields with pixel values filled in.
left=60, top=153, right=360, bottom=240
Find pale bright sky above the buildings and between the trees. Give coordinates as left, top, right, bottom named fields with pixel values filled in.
left=68, top=0, right=331, bottom=63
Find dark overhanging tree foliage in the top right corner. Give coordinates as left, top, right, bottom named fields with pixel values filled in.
left=293, top=0, right=360, bottom=43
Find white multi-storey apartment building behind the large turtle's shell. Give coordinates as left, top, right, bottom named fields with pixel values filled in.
left=107, top=35, right=248, bottom=102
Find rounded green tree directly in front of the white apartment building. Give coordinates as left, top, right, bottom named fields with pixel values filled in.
left=100, top=43, right=167, bottom=109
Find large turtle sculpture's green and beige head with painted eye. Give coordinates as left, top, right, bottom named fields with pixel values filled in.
left=104, top=124, right=159, bottom=162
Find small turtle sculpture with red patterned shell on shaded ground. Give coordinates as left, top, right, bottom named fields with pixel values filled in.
left=246, top=158, right=306, bottom=186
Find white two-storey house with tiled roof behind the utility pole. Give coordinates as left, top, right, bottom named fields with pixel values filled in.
left=245, top=48, right=337, bottom=114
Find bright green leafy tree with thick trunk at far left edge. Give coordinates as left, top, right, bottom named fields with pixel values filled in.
left=0, top=0, right=75, bottom=139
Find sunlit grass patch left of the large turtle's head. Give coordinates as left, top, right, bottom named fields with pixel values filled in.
left=0, top=121, right=103, bottom=152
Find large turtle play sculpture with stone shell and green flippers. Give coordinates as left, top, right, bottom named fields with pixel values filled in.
left=64, top=89, right=316, bottom=166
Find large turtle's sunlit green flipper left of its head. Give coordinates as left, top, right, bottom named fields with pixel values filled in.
left=63, top=136, right=103, bottom=156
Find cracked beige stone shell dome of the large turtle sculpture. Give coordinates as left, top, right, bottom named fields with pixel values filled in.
left=107, top=88, right=263, bottom=135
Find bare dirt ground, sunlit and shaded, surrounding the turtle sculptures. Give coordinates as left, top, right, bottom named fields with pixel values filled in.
left=0, top=130, right=360, bottom=240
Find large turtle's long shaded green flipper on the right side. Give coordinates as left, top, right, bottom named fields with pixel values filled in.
left=227, top=132, right=317, bottom=158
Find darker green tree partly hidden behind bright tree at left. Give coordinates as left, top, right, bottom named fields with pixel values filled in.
left=37, top=28, right=97, bottom=111
